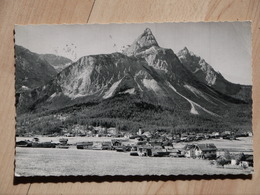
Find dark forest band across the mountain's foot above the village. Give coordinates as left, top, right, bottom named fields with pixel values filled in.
left=17, top=95, right=252, bottom=134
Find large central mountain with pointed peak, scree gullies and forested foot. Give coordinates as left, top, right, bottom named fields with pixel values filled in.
left=17, top=29, right=250, bottom=133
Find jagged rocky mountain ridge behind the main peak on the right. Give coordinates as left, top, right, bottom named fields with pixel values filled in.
left=177, top=47, right=252, bottom=102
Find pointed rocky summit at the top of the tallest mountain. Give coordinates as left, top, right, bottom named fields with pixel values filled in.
left=123, top=28, right=159, bottom=56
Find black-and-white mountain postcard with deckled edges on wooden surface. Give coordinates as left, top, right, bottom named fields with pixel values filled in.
left=14, top=21, right=254, bottom=177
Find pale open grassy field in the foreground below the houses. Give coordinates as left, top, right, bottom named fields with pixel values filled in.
left=15, top=147, right=252, bottom=176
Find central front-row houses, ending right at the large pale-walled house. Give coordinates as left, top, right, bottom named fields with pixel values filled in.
left=76, top=139, right=217, bottom=159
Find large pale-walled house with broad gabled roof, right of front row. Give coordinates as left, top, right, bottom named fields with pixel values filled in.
left=194, top=143, right=217, bottom=159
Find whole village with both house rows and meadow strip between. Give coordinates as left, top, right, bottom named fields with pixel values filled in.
left=16, top=126, right=253, bottom=169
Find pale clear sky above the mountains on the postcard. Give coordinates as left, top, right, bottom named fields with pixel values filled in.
left=15, top=22, right=252, bottom=85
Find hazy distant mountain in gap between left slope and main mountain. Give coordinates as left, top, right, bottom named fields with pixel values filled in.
left=40, top=54, right=72, bottom=73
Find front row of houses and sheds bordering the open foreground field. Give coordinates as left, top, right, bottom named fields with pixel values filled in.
left=16, top=133, right=253, bottom=167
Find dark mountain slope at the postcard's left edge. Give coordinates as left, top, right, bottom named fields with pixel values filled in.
left=15, top=45, right=57, bottom=92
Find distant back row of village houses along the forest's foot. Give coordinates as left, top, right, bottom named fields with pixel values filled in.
left=17, top=124, right=252, bottom=143
